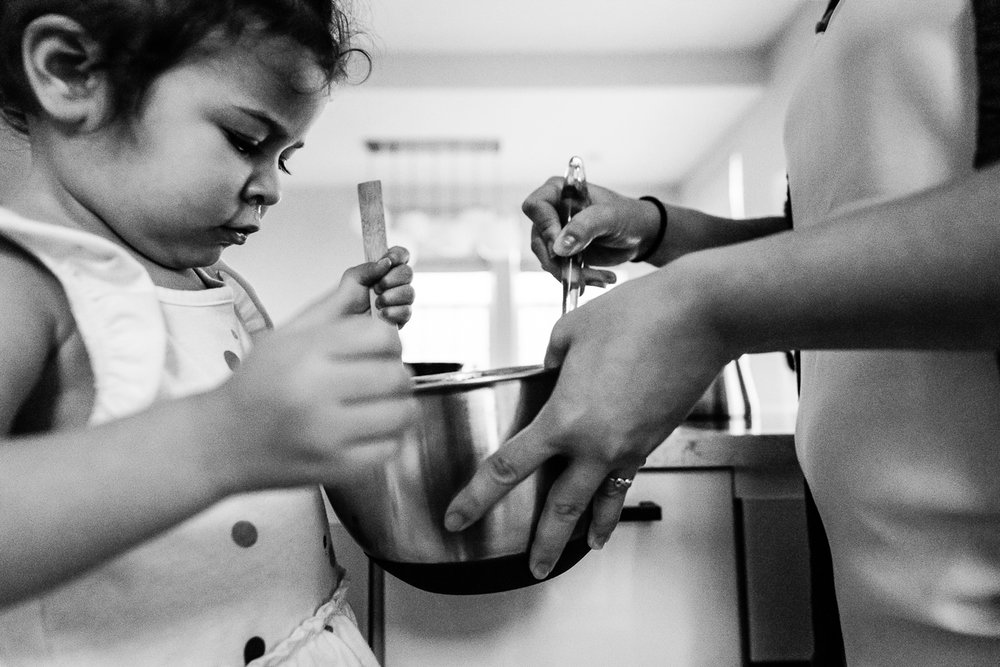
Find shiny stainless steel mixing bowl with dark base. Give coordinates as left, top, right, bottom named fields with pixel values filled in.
left=327, top=366, right=589, bottom=594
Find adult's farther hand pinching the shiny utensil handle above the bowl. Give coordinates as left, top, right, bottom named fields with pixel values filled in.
left=521, top=176, right=660, bottom=287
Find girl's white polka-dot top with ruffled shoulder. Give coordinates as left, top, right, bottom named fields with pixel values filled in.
left=0, top=209, right=374, bottom=666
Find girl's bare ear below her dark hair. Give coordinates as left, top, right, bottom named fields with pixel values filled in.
left=21, top=14, right=111, bottom=129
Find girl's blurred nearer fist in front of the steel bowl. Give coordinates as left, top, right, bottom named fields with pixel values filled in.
left=217, top=284, right=417, bottom=493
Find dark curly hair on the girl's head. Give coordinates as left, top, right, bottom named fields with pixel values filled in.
left=0, top=0, right=371, bottom=133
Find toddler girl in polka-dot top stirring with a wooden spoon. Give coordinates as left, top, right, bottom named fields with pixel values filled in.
left=0, top=0, right=416, bottom=665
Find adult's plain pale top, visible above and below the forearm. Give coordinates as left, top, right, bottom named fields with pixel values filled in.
left=786, top=0, right=1000, bottom=665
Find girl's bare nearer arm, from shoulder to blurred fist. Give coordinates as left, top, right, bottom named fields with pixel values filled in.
left=0, top=249, right=416, bottom=605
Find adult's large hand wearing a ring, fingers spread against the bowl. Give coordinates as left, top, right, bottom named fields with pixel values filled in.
left=445, top=269, right=732, bottom=578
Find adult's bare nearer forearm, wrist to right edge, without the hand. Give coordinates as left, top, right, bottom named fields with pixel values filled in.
left=675, top=170, right=1000, bottom=352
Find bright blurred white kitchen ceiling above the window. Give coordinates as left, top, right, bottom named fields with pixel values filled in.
left=290, top=0, right=822, bottom=192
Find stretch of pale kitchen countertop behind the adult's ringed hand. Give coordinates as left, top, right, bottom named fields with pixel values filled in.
left=643, top=414, right=798, bottom=471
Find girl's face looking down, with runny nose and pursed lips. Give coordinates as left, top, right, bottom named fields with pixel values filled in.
left=64, top=32, right=327, bottom=270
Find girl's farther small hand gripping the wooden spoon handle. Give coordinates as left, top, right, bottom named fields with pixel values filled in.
left=338, top=246, right=414, bottom=327
